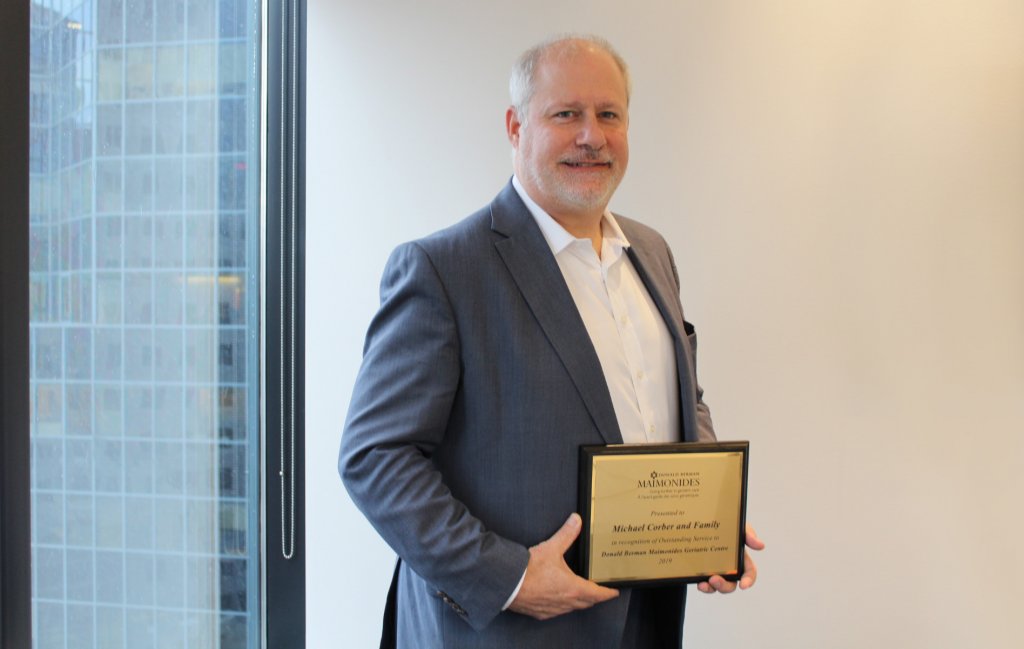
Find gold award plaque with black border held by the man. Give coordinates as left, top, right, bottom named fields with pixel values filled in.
left=580, top=441, right=750, bottom=588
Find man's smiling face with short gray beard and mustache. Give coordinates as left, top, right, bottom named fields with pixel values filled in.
left=506, top=47, right=629, bottom=221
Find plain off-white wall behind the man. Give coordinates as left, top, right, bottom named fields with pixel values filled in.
left=306, top=0, right=1024, bottom=649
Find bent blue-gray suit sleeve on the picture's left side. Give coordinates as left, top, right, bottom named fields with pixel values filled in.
left=339, top=244, right=529, bottom=629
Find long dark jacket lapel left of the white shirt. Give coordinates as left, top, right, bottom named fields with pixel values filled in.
left=490, top=183, right=623, bottom=444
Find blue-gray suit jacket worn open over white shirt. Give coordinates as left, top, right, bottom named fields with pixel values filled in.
left=339, top=183, right=714, bottom=649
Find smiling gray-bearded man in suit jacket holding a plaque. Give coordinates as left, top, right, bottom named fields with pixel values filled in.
left=339, top=37, right=761, bottom=649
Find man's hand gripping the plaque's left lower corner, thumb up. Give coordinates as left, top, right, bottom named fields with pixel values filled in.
left=509, top=514, right=618, bottom=619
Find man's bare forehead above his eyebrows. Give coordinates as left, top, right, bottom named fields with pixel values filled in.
left=531, top=46, right=627, bottom=107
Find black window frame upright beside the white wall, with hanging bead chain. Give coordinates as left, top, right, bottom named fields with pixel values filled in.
left=263, top=0, right=305, bottom=647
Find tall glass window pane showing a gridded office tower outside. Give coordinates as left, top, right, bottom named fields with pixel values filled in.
left=30, top=0, right=260, bottom=649
